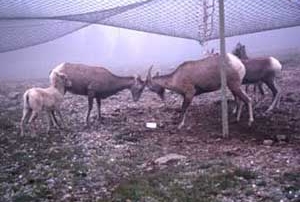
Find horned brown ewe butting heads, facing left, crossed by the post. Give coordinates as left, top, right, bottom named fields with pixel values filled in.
left=146, top=53, right=254, bottom=128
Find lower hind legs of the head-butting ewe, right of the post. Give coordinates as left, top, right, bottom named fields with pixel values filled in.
left=231, top=87, right=254, bottom=126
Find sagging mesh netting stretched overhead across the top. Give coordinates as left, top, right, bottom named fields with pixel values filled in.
left=0, top=0, right=300, bottom=52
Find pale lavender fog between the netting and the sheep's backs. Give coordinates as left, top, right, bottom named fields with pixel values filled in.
left=0, top=25, right=300, bottom=80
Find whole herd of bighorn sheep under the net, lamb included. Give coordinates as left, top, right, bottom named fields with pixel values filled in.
left=20, top=43, right=282, bottom=135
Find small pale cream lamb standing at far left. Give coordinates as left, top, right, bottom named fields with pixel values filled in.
left=20, top=72, right=72, bottom=136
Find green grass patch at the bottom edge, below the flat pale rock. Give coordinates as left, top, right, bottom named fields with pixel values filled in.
left=108, top=163, right=256, bottom=202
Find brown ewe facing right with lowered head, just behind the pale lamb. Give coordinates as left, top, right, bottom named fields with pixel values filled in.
left=50, top=63, right=145, bottom=124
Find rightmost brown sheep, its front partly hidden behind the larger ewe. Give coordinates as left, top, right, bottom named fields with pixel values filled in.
left=233, top=43, right=282, bottom=112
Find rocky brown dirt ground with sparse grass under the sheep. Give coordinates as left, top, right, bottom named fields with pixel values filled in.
left=0, top=54, right=300, bottom=202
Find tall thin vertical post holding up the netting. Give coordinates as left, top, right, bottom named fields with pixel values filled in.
left=219, top=0, right=229, bottom=137
